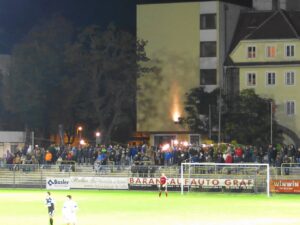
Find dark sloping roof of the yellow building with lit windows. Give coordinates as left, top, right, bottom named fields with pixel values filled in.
left=225, top=10, right=300, bottom=65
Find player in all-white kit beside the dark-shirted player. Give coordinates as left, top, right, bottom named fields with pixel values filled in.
left=62, top=195, right=78, bottom=225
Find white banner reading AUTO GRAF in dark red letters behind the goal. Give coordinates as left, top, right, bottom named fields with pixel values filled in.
left=128, top=177, right=254, bottom=189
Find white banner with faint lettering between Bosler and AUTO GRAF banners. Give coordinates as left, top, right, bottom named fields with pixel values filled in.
left=70, top=177, right=128, bottom=190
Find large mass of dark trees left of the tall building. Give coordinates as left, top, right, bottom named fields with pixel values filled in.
left=0, top=16, right=151, bottom=143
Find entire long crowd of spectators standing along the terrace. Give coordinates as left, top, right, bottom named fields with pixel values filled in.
left=6, top=144, right=300, bottom=171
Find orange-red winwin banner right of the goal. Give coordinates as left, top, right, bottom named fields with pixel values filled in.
left=270, top=180, right=300, bottom=193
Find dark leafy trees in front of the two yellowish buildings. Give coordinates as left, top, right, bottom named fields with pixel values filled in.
left=181, top=87, right=282, bottom=146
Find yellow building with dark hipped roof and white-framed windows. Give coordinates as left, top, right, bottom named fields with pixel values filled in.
left=226, top=10, right=300, bottom=145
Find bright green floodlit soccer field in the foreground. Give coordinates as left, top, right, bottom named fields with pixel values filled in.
left=0, top=189, right=300, bottom=225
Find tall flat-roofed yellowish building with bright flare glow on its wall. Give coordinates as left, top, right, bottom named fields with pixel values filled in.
left=137, top=0, right=252, bottom=145
